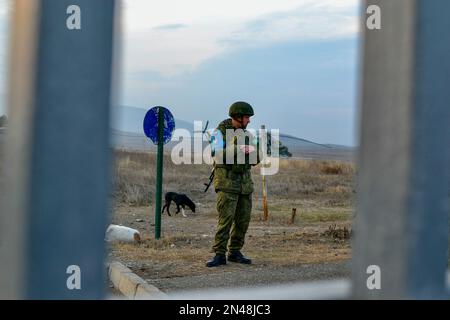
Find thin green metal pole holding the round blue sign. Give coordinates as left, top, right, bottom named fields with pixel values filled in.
left=155, top=107, right=164, bottom=240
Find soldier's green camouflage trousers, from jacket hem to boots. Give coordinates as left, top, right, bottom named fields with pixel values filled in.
left=213, top=191, right=252, bottom=254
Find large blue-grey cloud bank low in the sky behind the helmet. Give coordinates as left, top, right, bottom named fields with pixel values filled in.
left=121, top=37, right=358, bottom=144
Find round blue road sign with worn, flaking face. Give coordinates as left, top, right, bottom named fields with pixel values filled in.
left=144, top=107, right=175, bottom=144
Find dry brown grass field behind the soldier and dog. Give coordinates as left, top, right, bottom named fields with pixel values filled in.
left=109, top=151, right=355, bottom=279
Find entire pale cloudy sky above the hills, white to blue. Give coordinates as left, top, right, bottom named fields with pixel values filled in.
left=0, top=0, right=359, bottom=145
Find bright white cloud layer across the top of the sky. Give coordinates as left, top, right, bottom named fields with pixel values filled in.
left=123, top=0, right=358, bottom=77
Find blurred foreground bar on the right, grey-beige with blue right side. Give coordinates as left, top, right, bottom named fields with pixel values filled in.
left=353, top=0, right=450, bottom=299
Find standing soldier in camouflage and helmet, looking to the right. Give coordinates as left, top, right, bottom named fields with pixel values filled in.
left=206, top=101, right=260, bottom=267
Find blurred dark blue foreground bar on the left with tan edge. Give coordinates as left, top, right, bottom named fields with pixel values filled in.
left=0, top=0, right=115, bottom=299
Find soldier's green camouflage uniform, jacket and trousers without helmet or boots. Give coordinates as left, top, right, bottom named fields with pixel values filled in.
left=213, top=119, right=260, bottom=255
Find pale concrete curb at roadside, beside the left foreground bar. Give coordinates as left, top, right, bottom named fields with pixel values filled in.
left=108, top=262, right=167, bottom=300
